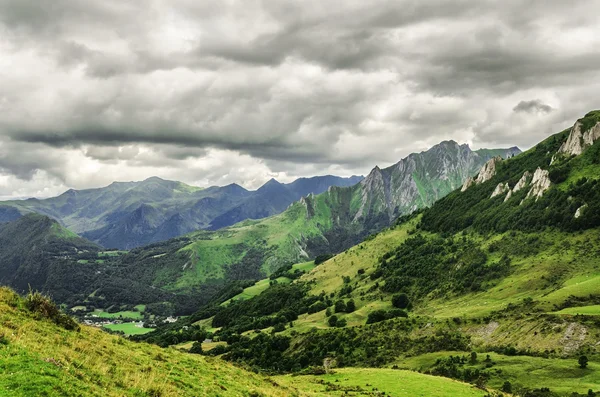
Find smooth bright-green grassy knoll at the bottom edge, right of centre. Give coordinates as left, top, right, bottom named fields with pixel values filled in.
left=274, top=368, right=486, bottom=397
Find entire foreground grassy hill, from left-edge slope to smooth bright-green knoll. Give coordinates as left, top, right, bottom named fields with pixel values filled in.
left=0, top=288, right=492, bottom=397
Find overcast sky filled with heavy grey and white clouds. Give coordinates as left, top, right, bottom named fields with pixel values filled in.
left=0, top=0, right=600, bottom=199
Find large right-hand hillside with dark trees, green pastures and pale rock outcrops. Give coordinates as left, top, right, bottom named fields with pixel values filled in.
left=140, top=111, right=600, bottom=397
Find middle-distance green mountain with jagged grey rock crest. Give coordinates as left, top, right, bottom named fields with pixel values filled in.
left=97, top=141, right=519, bottom=293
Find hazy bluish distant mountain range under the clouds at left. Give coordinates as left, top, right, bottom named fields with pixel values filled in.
left=0, top=175, right=362, bottom=249
